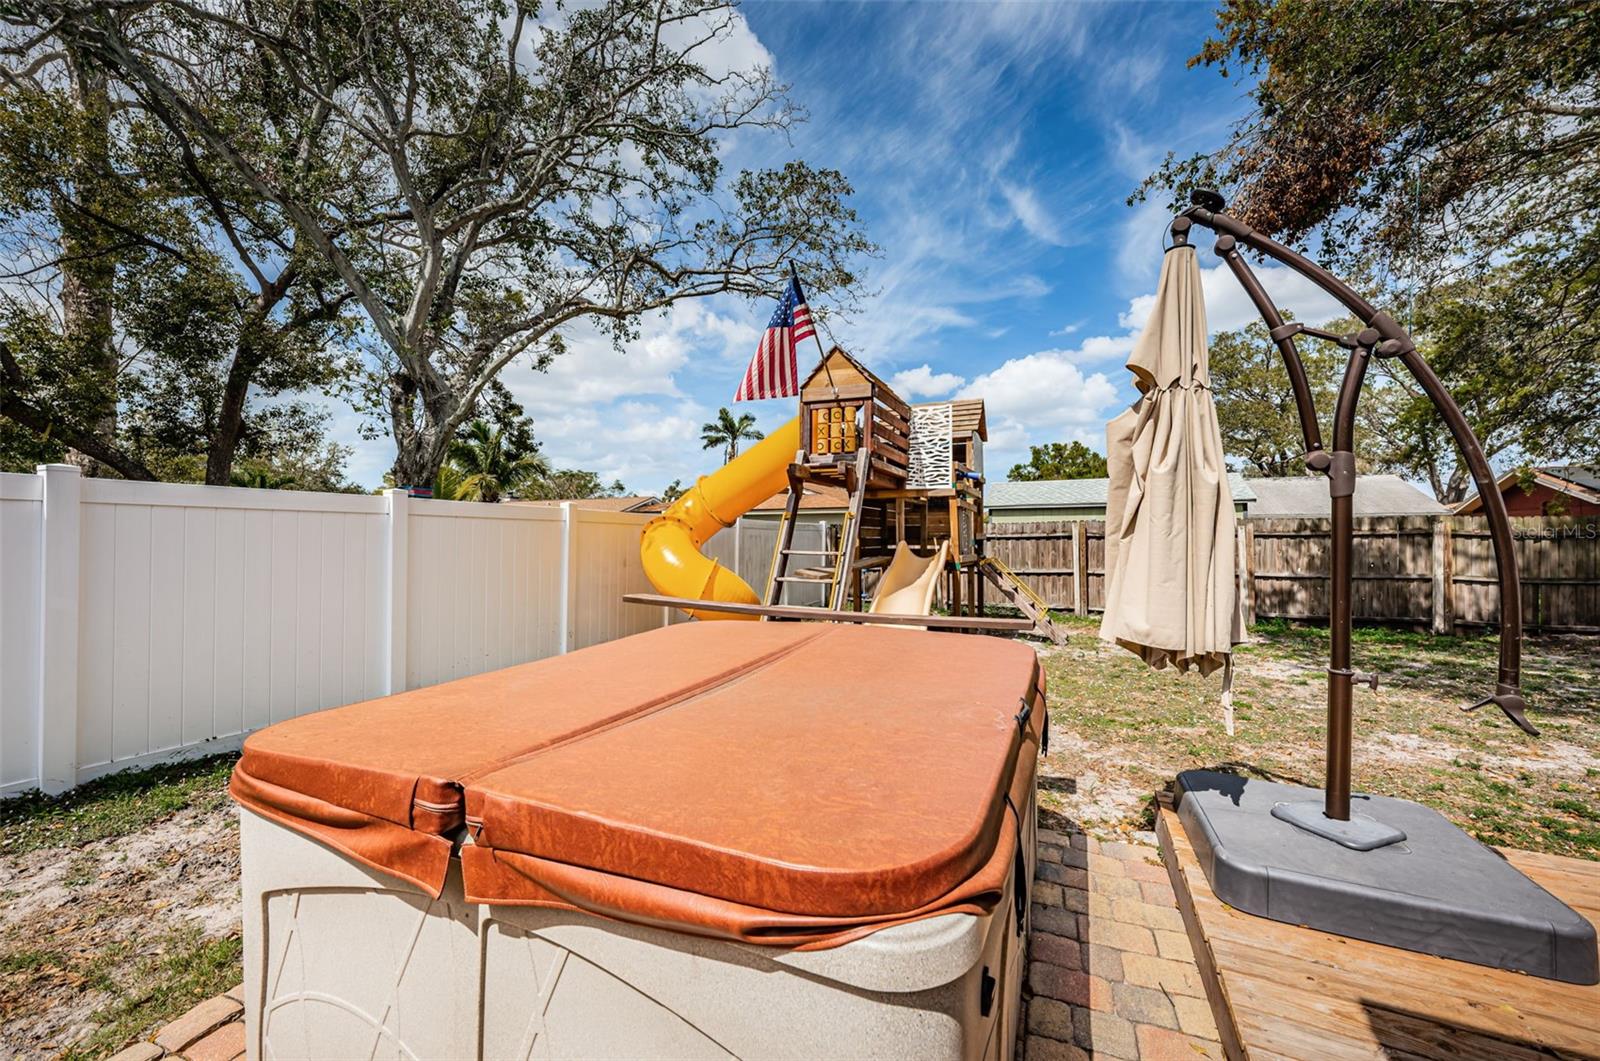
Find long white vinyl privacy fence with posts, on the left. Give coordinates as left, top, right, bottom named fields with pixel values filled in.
left=0, top=464, right=667, bottom=794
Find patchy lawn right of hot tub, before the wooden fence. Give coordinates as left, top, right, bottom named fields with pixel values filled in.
left=1040, top=616, right=1600, bottom=859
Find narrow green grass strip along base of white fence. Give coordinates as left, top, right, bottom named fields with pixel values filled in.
left=0, top=754, right=238, bottom=855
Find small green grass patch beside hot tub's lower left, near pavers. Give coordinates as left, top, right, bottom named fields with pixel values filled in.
left=61, top=927, right=243, bottom=1061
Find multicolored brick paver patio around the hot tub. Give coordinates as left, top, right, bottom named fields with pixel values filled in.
left=112, top=829, right=1222, bottom=1061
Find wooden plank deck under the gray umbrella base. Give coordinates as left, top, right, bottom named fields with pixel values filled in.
left=1157, top=807, right=1600, bottom=1061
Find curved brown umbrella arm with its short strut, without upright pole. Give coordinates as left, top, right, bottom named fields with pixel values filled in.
left=1173, top=192, right=1538, bottom=735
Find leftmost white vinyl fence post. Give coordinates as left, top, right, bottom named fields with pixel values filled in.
left=37, top=464, right=83, bottom=795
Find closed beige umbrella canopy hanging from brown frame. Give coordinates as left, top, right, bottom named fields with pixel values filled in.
left=1101, top=246, right=1243, bottom=716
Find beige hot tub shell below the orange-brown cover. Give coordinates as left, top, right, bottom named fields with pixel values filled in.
left=240, top=803, right=1034, bottom=1061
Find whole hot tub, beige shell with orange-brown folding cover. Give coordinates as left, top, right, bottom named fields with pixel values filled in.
left=232, top=623, right=1045, bottom=1058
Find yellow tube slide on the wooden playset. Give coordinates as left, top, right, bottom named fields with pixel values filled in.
left=638, top=416, right=800, bottom=619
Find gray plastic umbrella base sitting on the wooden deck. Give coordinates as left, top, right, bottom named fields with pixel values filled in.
left=1176, top=770, right=1600, bottom=984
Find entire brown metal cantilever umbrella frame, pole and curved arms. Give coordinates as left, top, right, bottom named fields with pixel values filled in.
left=1171, top=190, right=1539, bottom=847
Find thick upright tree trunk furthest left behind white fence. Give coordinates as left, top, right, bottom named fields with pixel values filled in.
left=56, top=48, right=118, bottom=470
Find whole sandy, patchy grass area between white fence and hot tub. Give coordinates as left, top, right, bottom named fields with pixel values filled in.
left=0, top=755, right=240, bottom=1058
